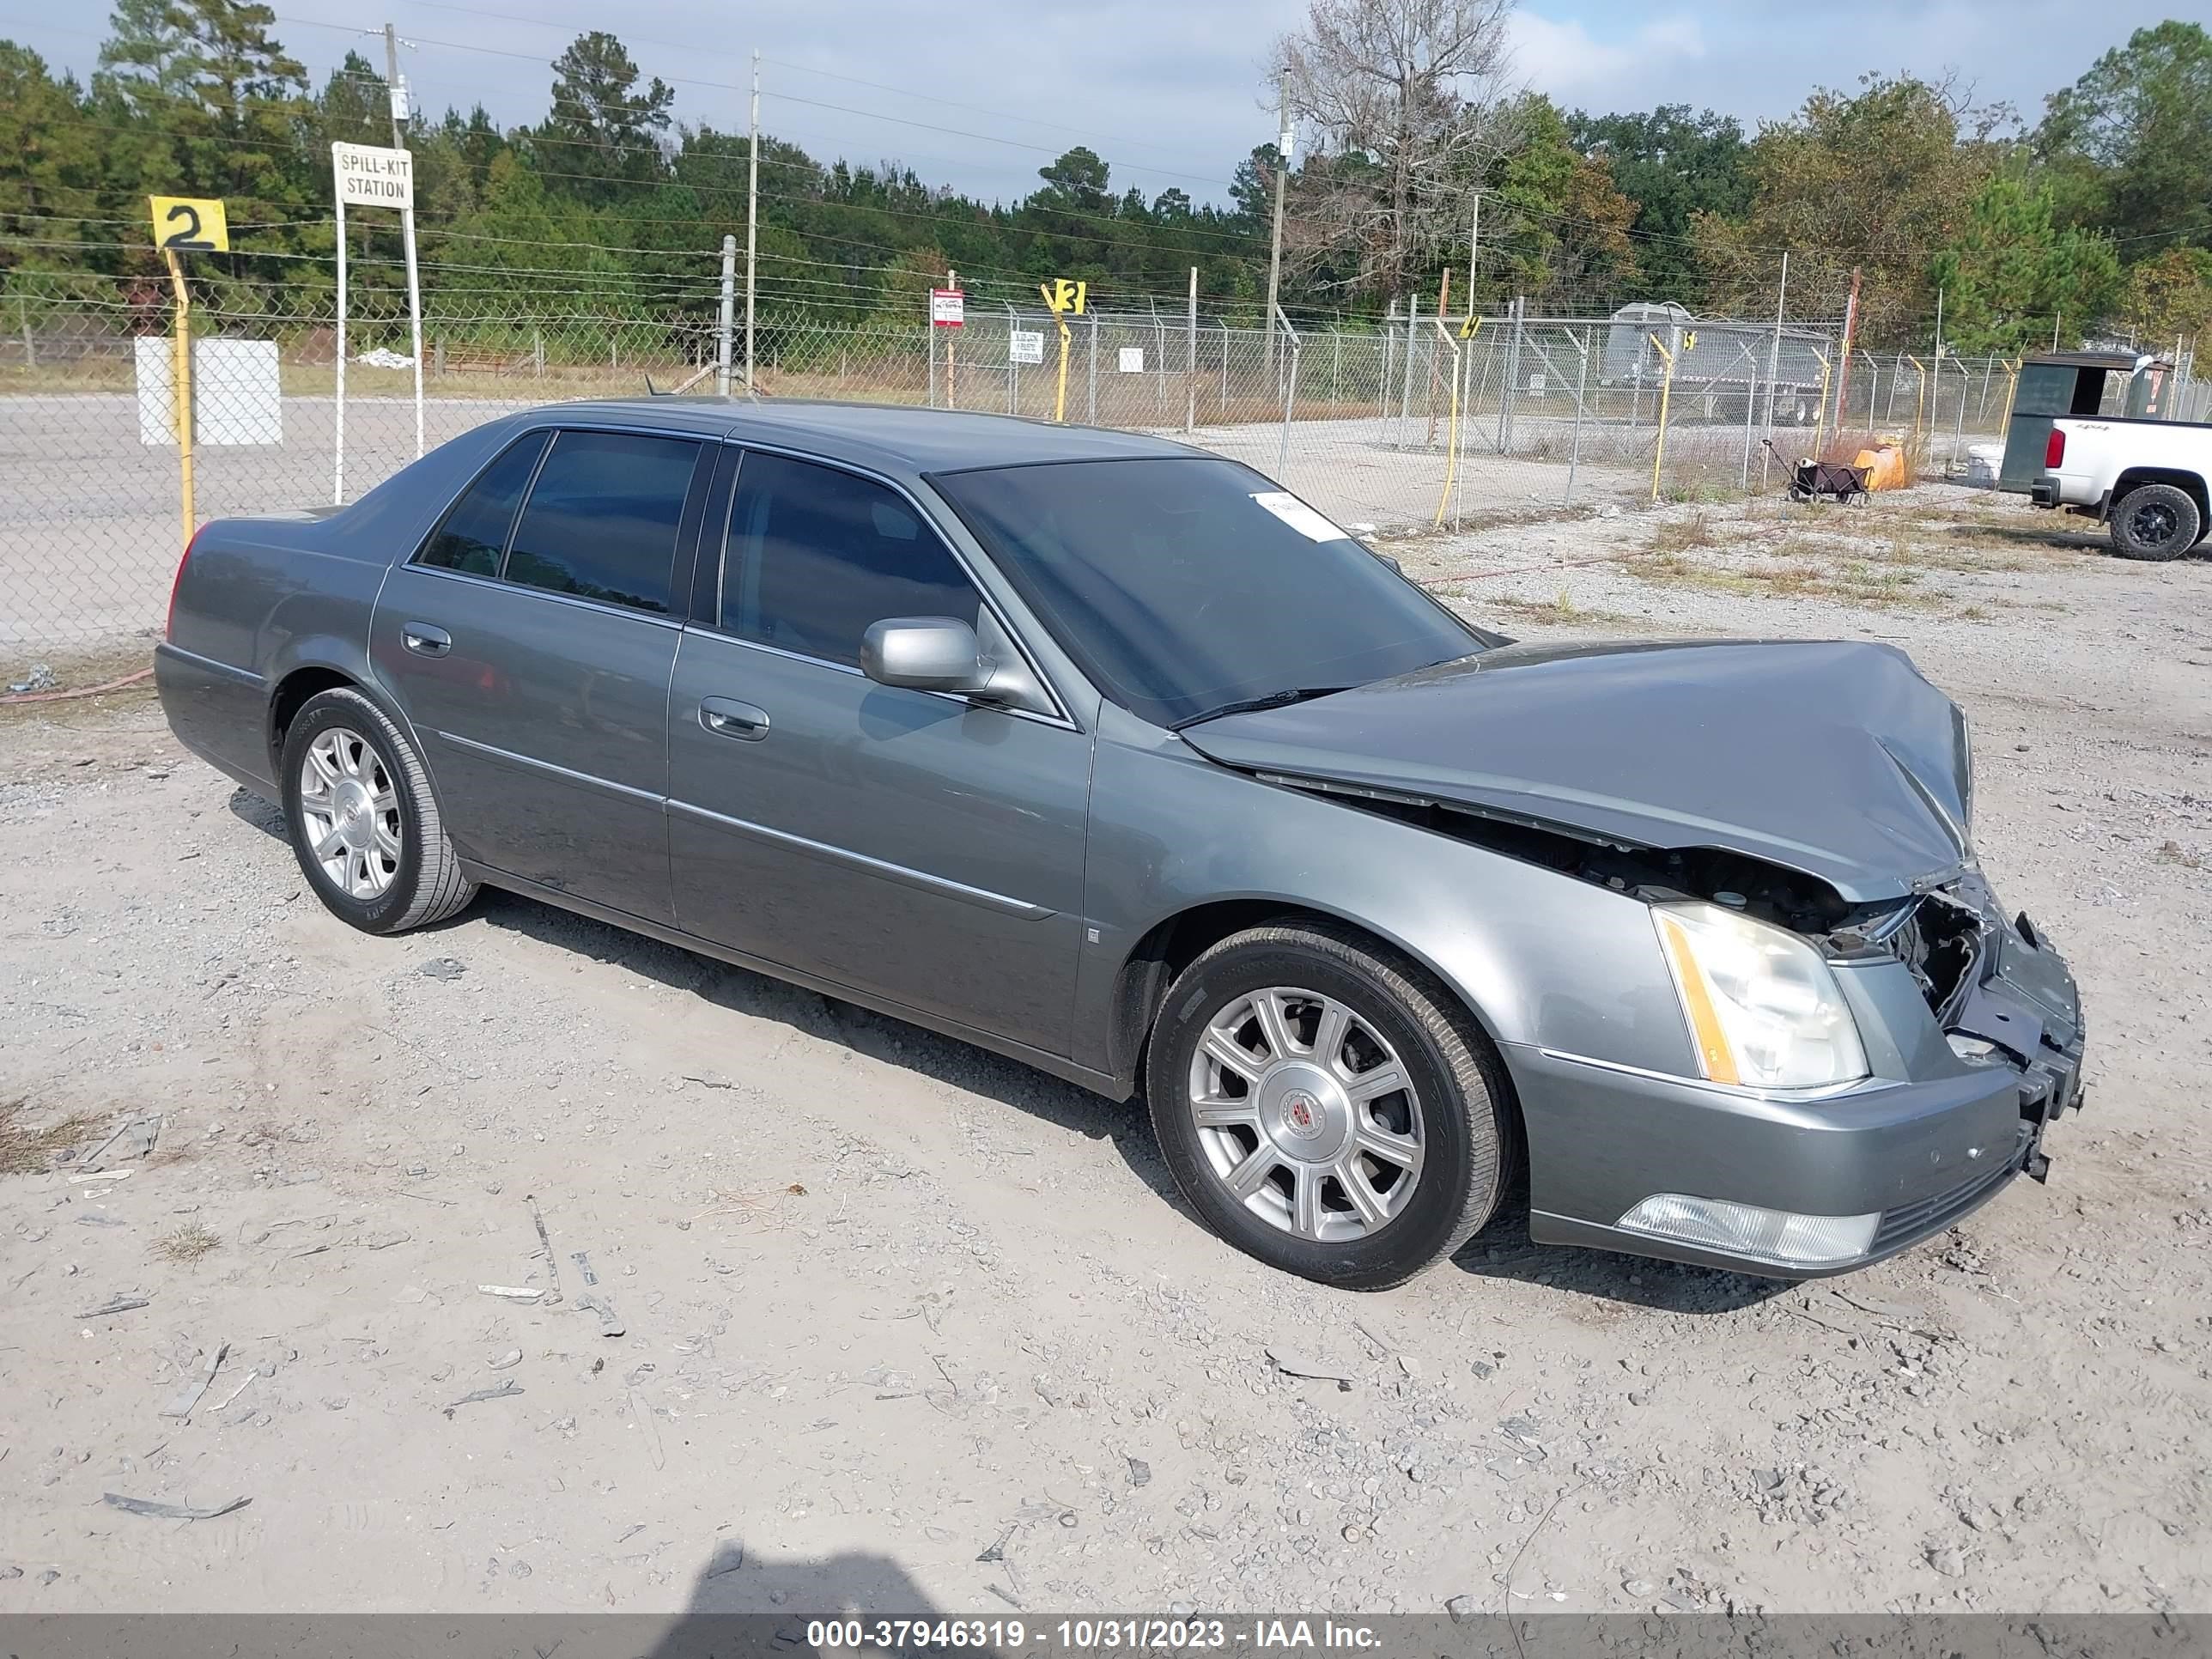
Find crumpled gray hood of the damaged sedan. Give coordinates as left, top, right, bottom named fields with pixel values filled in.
left=1182, top=639, right=1973, bottom=902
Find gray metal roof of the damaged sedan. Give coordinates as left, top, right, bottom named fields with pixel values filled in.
left=529, top=398, right=1207, bottom=473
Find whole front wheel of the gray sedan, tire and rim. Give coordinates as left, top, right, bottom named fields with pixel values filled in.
left=1146, top=918, right=1516, bottom=1290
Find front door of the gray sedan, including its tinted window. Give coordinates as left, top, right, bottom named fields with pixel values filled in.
left=668, top=449, right=1091, bottom=1055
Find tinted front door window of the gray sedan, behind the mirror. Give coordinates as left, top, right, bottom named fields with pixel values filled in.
left=721, top=453, right=980, bottom=664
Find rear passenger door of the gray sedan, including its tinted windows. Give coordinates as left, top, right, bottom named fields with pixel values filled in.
left=369, top=427, right=708, bottom=922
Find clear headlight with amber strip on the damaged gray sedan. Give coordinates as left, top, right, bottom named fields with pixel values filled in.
left=1652, top=905, right=1867, bottom=1088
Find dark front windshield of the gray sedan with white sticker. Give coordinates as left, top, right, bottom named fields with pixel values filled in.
left=931, top=456, right=1484, bottom=726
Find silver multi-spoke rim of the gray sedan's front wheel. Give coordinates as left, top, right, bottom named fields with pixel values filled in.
left=1188, top=984, right=1425, bottom=1243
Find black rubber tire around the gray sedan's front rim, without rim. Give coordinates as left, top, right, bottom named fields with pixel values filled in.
left=1146, top=942, right=1504, bottom=1290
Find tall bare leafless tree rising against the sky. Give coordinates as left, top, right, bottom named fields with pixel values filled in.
left=1274, top=0, right=1513, bottom=299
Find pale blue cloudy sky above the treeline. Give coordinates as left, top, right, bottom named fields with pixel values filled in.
left=0, top=0, right=2205, bottom=199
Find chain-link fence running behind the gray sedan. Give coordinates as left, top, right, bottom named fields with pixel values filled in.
left=0, top=272, right=2176, bottom=659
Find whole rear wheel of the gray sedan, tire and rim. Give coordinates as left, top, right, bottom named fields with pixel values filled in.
left=279, top=688, right=476, bottom=933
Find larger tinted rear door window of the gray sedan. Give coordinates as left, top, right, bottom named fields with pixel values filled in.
left=507, top=431, right=699, bottom=611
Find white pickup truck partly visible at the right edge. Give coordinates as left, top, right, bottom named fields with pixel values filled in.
left=2028, top=416, right=2212, bottom=560
